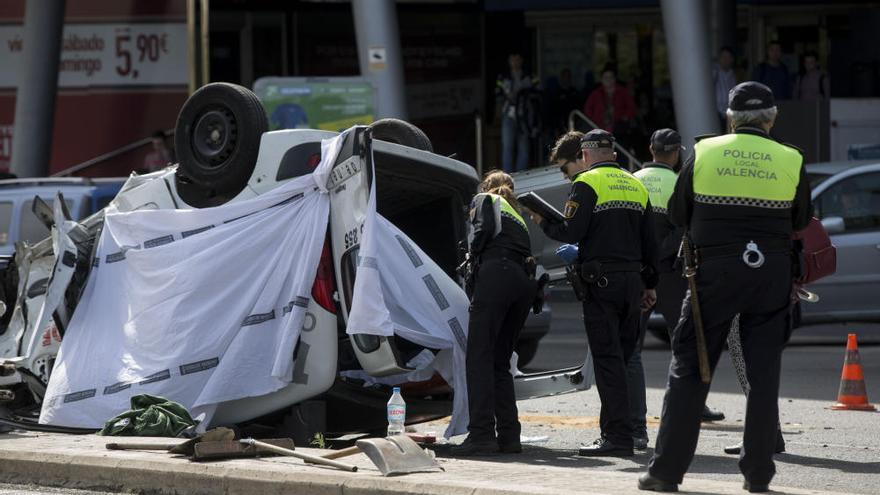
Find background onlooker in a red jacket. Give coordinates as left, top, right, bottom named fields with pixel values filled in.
left=584, top=66, right=636, bottom=134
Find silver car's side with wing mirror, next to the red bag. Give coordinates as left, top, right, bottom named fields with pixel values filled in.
left=801, top=166, right=880, bottom=323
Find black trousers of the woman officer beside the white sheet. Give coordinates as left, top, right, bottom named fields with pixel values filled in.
left=466, top=258, right=536, bottom=443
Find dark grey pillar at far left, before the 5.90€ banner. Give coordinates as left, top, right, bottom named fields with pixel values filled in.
left=10, top=0, right=65, bottom=177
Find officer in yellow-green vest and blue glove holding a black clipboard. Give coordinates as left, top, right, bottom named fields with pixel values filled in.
left=530, top=130, right=657, bottom=457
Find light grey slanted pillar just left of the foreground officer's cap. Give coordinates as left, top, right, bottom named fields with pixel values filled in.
left=660, top=0, right=719, bottom=149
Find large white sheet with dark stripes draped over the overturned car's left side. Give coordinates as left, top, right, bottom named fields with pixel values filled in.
left=40, top=172, right=330, bottom=428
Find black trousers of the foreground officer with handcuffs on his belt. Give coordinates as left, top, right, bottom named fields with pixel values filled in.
left=649, top=253, right=792, bottom=484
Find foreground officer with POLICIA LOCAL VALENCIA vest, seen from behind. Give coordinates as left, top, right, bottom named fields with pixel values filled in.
left=639, top=82, right=812, bottom=492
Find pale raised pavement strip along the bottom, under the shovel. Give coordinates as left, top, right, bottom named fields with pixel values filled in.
left=0, top=432, right=852, bottom=495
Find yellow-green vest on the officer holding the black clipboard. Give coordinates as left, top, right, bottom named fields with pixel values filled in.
left=574, top=167, right=648, bottom=213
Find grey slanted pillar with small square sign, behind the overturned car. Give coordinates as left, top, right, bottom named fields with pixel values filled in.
left=351, top=0, right=407, bottom=119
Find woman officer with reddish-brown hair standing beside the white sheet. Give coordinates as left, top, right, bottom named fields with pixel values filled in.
left=452, top=170, right=537, bottom=456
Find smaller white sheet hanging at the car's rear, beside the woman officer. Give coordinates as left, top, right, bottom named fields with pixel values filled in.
left=346, top=170, right=470, bottom=438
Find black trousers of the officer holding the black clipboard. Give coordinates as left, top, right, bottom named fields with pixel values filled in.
left=584, top=272, right=643, bottom=447
